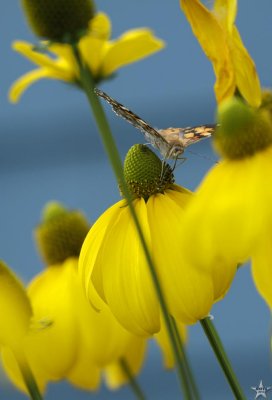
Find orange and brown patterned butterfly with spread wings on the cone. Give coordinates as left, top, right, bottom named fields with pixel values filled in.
left=94, top=89, right=216, bottom=160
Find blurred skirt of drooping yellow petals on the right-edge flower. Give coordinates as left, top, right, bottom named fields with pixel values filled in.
left=182, top=148, right=272, bottom=278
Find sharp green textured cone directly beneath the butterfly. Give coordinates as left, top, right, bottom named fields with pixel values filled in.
left=121, top=144, right=174, bottom=201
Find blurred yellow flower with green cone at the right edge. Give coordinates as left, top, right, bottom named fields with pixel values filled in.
left=177, top=99, right=272, bottom=306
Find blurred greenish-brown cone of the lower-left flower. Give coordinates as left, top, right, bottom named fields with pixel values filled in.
left=34, top=202, right=90, bottom=265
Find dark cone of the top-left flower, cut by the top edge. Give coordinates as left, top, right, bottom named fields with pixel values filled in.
left=22, top=0, right=95, bottom=42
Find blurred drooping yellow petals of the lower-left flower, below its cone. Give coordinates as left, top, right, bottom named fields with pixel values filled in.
left=2, top=258, right=146, bottom=391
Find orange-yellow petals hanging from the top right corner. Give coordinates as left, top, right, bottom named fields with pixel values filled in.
left=180, top=0, right=261, bottom=107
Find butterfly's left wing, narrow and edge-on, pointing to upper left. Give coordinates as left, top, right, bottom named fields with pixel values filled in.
left=95, top=89, right=172, bottom=155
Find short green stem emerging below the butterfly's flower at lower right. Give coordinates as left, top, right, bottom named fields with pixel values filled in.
left=200, top=317, right=246, bottom=400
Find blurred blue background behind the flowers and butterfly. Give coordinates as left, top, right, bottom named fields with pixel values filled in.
left=0, top=0, right=272, bottom=400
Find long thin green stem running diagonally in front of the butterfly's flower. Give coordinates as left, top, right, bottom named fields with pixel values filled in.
left=72, top=44, right=191, bottom=400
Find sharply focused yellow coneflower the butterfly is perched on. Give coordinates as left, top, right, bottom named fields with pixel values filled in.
left=79, top=145, right=236, bottom=328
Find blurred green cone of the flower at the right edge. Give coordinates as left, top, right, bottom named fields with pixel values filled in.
left=214, top=98, right=272, bottom=159
